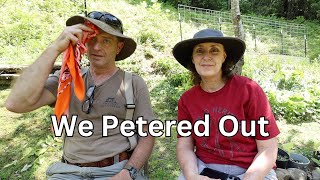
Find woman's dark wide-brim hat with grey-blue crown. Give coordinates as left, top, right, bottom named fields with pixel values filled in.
left=172, top=29, right=246, bottom=69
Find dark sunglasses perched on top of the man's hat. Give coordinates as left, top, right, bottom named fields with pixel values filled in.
left=88, top=11, right=123, bottom=34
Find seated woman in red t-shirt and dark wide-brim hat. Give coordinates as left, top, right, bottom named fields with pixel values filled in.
left=173, top=29, right=280, bottom=180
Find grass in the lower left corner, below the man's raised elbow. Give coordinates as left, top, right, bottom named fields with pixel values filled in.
left=0, top=89, right=61, bottom=179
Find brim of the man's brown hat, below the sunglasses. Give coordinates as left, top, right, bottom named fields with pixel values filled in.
left=66, top=16, right=137, bottom=61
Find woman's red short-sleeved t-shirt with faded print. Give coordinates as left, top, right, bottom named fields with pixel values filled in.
left=178, top=75, right=280, bottom=168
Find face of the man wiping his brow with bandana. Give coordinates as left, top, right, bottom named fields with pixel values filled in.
left=87, top=31, right=124, bottom=67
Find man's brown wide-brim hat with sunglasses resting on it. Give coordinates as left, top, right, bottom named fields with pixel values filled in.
left=66, top=11, right=137, bottom=61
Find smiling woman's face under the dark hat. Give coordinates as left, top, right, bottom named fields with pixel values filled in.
left=192, top=42, right=227, bottom=78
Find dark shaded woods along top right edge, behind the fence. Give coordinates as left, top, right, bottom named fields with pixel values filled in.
left=162, top=0, right=320, bottom=20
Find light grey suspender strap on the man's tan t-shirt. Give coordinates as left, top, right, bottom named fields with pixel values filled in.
left=124, top=72, right=138, bottom=151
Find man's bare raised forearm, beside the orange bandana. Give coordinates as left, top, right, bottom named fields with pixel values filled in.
left=6, top=46, right=59, bottom=112
